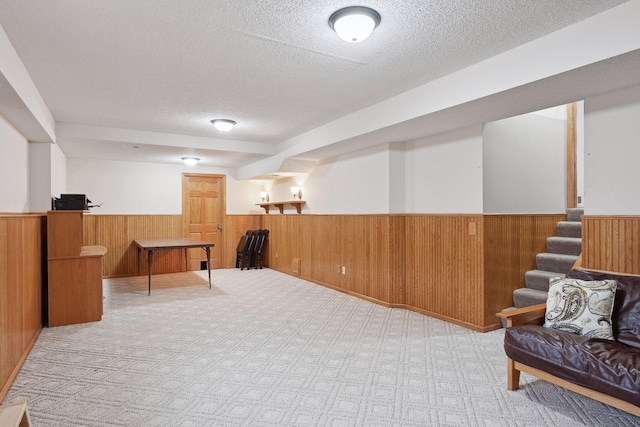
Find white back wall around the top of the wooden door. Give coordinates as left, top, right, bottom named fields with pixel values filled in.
left=67, top=158, right=260, bottom=215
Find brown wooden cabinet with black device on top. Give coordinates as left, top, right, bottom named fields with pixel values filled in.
left=47, top=211, right=107, bottom=327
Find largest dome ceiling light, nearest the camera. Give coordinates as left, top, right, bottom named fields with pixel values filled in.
left=329, top=6, right=380, bottom=43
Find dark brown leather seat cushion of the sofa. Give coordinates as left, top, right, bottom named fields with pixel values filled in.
left=504, top=325, right=640, bottom=406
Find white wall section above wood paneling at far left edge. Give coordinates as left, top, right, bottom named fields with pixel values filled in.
left=0, top=116, right=29, bottom=213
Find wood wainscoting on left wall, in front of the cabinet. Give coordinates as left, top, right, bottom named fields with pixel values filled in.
left=0, top=215, right=47, bottom=402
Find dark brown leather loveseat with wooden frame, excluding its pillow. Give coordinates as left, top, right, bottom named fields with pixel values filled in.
left=499, top=270, right=640, bottom=416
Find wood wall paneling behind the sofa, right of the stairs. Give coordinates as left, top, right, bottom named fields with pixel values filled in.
left=582, top=215, right=640, bottom=274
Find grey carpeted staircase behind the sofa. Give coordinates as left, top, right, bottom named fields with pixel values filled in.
left=507, top=208, right=584, bottom=316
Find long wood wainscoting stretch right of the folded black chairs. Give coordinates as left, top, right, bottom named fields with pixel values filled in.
left=262, top=215, right=404, bottom=306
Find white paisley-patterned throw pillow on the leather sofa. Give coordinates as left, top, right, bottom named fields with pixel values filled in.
left=543, top=277, right=618, bottom=340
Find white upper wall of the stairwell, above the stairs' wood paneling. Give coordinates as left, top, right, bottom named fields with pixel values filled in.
left=483, top=114, right=567, bottom=213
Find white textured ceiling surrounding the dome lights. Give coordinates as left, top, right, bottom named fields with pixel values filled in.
left=0, top=0, right=624, bottom=172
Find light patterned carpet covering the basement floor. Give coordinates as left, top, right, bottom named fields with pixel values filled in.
left=5, top=269, right=640, bottom=427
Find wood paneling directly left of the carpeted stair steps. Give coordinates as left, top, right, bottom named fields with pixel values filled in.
left=484, top=214, right=566, bottom=326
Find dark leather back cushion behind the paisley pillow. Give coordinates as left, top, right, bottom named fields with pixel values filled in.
left=567, top=270, right=640, bottom=349
